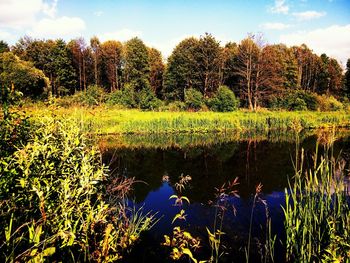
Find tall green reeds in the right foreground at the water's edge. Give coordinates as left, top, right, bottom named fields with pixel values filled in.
left=284, top=131, right=350, bottom=262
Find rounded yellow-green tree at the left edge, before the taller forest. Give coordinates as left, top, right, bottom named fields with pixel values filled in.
left=0, top=52, right=49, bottom=97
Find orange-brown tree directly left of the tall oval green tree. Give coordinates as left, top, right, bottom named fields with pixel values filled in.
left=101, top=40, right=122, bottom=92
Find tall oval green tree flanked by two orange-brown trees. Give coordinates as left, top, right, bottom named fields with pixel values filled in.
left=124, top=37, right=150, bottom=91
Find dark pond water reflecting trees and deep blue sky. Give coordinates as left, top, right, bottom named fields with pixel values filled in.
left=103, top=134, right=350, bottom=262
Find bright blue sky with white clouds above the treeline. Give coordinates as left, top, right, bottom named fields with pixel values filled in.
left=0, top=0, right=350, bottom=65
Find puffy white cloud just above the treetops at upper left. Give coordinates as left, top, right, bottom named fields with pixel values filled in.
left=27, top=16, right=85, bottom=38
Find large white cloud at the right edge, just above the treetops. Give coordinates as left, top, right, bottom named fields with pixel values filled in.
left=280, top=24, right=350, bottom=65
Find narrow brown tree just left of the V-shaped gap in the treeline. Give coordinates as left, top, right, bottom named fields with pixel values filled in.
left=148, top=48, right=165, bottom=97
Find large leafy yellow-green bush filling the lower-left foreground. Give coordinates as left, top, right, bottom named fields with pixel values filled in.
left=0, top=118, right=155, bottom=262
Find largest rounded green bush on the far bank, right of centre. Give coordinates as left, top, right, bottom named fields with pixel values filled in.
left=208, top=86, right=239, bottom=112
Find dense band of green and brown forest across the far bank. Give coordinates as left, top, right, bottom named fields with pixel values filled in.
left=0, top=34, right=350, bottom=111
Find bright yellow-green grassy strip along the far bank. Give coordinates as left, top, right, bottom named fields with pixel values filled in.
left=22, top=106, right=350, bottom=134
